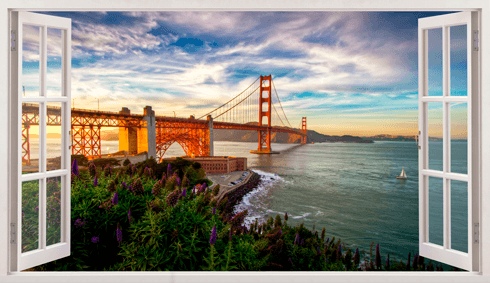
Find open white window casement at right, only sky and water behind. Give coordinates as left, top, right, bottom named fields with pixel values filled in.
left=418, top=12, right=480, bottom=271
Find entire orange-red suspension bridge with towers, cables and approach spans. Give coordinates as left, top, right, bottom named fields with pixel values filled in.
left=22, top=75, right=307, bottom=165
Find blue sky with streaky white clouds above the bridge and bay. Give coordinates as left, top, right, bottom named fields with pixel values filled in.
left=23, top=12, right=466, bottom=137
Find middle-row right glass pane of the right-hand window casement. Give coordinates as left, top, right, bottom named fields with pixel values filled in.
left=449, top=102, right=468, bottom=174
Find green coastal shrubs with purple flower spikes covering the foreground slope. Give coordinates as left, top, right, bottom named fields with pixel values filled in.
left=22, top=158, right=452, bottom=271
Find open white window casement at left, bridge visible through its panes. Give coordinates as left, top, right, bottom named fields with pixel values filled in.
left=10, top=12, right=71, bottom=271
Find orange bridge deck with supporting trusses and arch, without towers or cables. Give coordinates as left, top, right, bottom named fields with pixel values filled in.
left=22, top=103, right=304, bottom=163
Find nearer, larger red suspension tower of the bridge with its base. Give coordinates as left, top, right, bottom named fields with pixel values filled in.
left=250, top=75, right=279, bottom=154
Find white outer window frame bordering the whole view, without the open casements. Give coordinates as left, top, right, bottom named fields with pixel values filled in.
left=0, top=0, right=490, bottom=282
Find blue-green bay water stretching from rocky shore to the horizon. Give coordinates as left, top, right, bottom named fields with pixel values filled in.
left=32, top=141, right=468, bottom=270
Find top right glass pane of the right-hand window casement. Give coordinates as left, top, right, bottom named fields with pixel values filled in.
left=449, top=25, right=468, bottom=96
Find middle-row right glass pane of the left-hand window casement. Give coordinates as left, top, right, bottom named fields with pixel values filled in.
left=46, top=102, right=62, bottom=171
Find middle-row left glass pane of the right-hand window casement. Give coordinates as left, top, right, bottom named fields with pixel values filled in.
left=427, top=102, right=443, bottom=171
